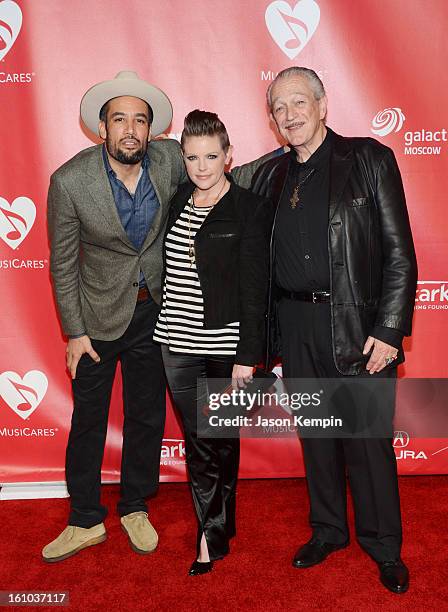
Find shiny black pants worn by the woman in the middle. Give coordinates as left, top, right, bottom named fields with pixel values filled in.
left=162, top=345, right=240, bottom=561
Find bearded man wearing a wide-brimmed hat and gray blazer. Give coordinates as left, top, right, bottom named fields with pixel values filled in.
left=42, top=71, right=186, bottom=562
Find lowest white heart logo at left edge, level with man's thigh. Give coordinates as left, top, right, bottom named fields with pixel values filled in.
left=0, top=370, right=48, bottom=420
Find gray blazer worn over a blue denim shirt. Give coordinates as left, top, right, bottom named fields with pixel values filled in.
left=48, top=140, right=187, bottom=340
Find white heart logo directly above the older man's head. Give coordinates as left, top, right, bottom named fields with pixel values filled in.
left=265, top=0, right=320, bottom=59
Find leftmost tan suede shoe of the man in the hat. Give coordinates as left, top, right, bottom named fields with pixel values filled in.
left=42, top=523, right=106, bottom=563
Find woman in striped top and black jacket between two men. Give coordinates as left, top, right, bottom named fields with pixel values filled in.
left=154, top=110, right=271, bottom=575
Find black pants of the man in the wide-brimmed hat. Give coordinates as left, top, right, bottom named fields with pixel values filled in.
left=66, top=298, right=166, bottom=528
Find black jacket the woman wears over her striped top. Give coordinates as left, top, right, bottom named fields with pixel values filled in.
left=164, top=179, right=272, bottom=366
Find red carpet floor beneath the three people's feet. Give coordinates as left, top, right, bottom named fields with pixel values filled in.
left=0, top=476, right=448, bottom=612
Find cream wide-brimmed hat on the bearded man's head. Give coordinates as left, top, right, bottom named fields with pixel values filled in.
left=80, top=70, right=173, bottom=136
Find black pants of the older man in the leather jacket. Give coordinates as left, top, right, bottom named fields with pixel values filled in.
left=279, top=298, right=402, bottom=561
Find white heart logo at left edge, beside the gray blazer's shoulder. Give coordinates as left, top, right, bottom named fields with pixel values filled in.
left=0, top=196, right=36, bottom=249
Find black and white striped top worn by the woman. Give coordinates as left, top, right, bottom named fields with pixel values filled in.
left=154, top=198, right=239, bottom=355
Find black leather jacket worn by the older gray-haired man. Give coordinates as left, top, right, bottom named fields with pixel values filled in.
left=235, top=128, right=417, bottom=375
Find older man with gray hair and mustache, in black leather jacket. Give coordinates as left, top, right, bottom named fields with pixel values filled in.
left=234, top=67, right=417, bottom=593
